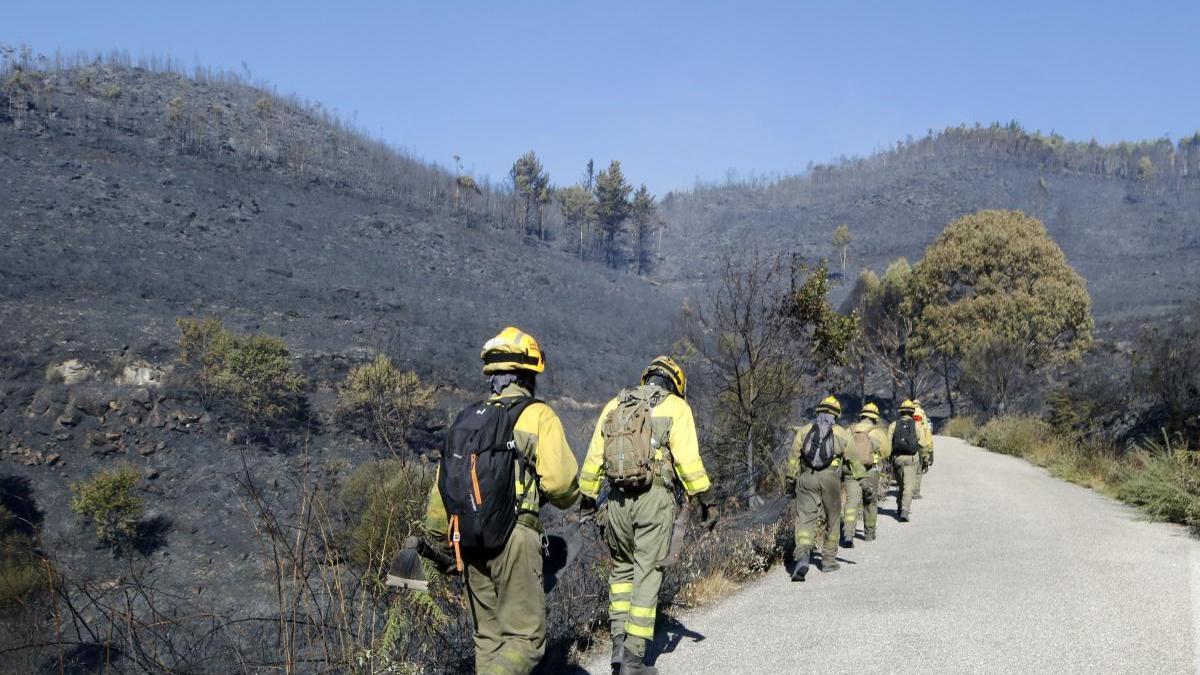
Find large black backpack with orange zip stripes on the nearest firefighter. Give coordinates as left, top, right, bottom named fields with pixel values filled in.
left=438, top=396, right=536, bottom=552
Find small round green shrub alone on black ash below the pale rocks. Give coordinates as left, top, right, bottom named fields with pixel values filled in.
left=71, top=466, right=144, bottom=548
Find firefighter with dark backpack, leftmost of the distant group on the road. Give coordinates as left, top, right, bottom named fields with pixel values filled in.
left=784, top=396, right=851, bottom=581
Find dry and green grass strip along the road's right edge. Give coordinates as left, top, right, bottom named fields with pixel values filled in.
left=943, top=416, right=1200, bottom=534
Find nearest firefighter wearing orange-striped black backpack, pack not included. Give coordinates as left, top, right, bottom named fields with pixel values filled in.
left=425, top=327, right=578, bottom=675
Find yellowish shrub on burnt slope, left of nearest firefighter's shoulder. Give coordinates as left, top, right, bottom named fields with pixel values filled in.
left=335, top=354, right=437, bottom=453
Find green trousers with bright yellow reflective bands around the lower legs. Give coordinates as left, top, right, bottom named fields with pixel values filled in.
left=605, top=482, right=676, bottom=657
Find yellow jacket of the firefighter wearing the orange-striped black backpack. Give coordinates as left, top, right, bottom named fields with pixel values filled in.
left=425, top=383, right=580, bottom=538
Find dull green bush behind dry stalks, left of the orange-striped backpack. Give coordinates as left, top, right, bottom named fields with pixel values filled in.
left=338, top=459, right=433, bottom=573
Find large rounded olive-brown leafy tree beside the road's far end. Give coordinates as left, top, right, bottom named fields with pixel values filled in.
left=908, top=210, right=1092, bottom=413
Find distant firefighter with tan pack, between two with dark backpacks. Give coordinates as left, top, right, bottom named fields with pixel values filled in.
left=841, top=404, right=892, bottom=540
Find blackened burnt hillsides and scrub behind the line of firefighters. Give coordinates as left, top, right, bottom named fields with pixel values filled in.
left=0, top=40, right=1200, bottom=673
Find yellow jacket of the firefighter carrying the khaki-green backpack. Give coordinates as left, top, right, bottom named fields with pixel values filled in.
left=580, top=384, right=712, bottom=498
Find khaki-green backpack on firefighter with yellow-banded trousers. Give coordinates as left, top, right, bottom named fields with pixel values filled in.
left=601, top=387, right=662, bottom=490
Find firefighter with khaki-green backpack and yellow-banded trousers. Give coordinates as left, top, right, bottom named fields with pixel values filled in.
left=580, top=357, right=716, bottom=675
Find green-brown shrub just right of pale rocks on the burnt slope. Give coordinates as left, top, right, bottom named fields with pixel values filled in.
left=176, top=317, right=305, bottom=424
